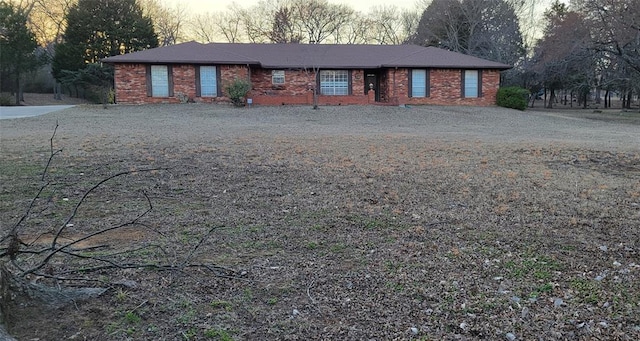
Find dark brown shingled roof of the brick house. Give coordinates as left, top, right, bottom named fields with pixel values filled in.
left=103, top=42, right=510, bottom=70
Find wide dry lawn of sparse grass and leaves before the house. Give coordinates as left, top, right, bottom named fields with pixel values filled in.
left=0, top=104, right=640, bottom=340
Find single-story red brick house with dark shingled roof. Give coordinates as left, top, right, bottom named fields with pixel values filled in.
left=103, top=42, right=510, bottom=106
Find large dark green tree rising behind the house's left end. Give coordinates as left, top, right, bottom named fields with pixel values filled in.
left=53, top=0, right=158, bottom=80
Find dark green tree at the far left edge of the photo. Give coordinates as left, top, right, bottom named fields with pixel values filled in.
left=0, top=1, right=41, bottom=105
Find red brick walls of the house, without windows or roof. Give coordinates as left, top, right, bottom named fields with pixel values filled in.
left=115, top=64, right=500, bottom=106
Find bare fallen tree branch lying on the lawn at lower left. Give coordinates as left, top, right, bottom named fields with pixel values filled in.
left=0, top=122, right=242, bottom=339
